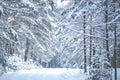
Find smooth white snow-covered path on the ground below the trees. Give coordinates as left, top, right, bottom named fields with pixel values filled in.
left=0, top=68, right=85, bottom=80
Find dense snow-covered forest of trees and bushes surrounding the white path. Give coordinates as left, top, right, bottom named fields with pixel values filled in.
left=0, top=0, right=120, bottom=80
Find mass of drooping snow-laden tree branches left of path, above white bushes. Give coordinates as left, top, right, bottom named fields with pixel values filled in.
left=0, top=0, right=56, bottom=73
